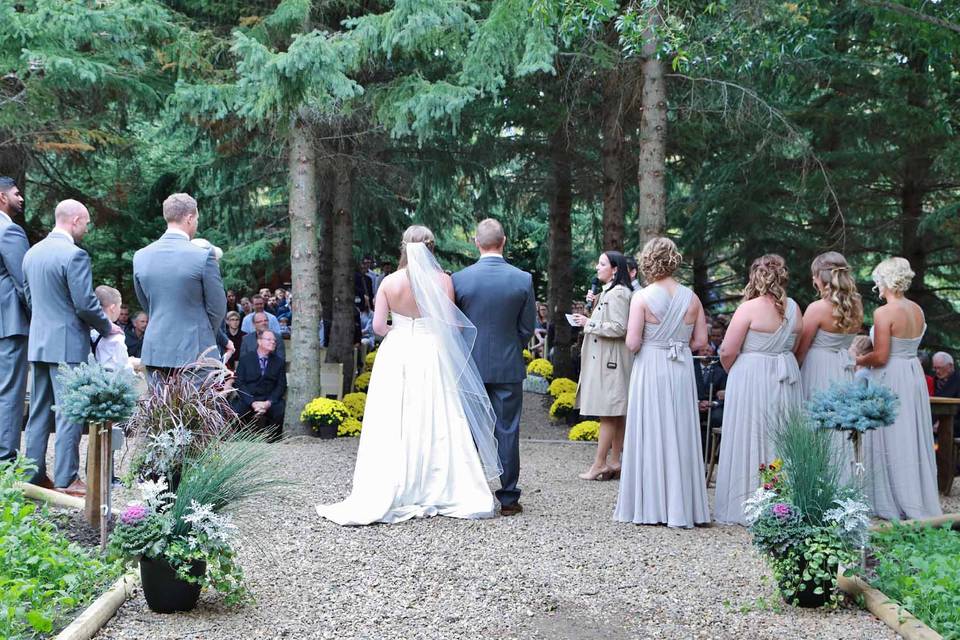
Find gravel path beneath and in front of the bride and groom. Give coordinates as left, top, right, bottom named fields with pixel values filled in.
left=86, top=392, right=960, bottom=640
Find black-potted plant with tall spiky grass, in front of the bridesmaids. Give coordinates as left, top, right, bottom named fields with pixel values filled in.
left=744, top=414, right=870, bottom=607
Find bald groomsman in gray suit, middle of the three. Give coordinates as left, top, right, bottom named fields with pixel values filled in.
left=23, top=200, right=114, bottom=495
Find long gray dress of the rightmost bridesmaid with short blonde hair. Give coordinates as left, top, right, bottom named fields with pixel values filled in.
left=863, top=326, right=942, bottom=520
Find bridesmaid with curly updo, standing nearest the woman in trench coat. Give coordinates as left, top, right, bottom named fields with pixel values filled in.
left=613, top=238, right=710, bottom=528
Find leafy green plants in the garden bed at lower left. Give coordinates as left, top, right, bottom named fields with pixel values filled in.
left=0, top=459, right=121, bottom=639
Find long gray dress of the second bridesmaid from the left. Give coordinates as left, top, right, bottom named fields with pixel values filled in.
left=714, top=299, right=803, bottom=524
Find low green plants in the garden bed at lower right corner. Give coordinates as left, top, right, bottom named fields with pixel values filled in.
left=871, top=525, right=960, bottom=640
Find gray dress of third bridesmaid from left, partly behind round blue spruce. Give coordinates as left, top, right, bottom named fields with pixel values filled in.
left=800, top=329, right=856, bottom=482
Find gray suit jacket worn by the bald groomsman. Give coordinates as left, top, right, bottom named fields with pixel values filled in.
left=23, top=233, right=113, bottom=364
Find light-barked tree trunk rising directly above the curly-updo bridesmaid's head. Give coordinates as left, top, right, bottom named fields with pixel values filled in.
left=637, top=5, right=667, bottom=246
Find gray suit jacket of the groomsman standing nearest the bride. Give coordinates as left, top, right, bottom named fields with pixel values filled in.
left=133, top=232, right=227, bottom=367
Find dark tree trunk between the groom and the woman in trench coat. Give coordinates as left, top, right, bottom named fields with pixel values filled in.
left=547, top=124, right=573, bottom=377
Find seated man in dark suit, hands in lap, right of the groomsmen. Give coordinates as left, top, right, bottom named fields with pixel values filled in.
left=233, top=329, right=287, bottom=441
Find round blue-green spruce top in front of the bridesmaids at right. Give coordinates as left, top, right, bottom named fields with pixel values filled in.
left=807, top=380, right=900, bottom=433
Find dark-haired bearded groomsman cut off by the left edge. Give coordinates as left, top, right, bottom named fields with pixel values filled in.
left=0, top=177, right=30, bottom=462
